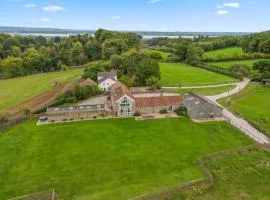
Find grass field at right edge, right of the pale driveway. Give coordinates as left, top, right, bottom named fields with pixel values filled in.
left=221, top=84, right=270, bottom=136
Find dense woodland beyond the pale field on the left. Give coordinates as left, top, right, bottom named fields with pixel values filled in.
left=0, top=29, right=141, bottom=78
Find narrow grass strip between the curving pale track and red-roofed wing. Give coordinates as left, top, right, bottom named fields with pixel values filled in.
left=167, top=85, right=236, bottom=96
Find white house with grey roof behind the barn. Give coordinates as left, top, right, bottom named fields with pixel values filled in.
left=97, top=72, right=117, bottom=91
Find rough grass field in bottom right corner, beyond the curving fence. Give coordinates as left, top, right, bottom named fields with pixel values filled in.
left=171, top=150, right=270, bottom=200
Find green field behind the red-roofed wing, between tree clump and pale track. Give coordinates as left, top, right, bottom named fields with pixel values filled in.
left=160, top=63, right=236, bottom=86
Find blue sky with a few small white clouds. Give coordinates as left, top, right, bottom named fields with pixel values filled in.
left=0, top=0, right=270, bottom=32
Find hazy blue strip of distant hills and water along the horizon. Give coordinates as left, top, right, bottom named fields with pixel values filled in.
left=0, top=26, right=250, bottom=37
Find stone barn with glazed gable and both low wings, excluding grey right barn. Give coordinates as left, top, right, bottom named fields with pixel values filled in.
left=46, top=82, right=183, bottom=121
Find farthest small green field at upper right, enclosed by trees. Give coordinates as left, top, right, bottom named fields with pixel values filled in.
left=203, top=47, right=244, bottom=58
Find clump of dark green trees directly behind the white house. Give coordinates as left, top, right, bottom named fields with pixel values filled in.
left=83, top=49, right=160, bottom=86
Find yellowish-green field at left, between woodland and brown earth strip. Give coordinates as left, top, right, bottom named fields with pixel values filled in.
left=0, top=70, right=82, bottom=113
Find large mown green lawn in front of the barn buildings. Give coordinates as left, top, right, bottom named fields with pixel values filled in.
left=0, top=118, right=252, bottom=200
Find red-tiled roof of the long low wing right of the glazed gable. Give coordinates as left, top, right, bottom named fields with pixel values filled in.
left=135, top=95, right=183, bottom=108
